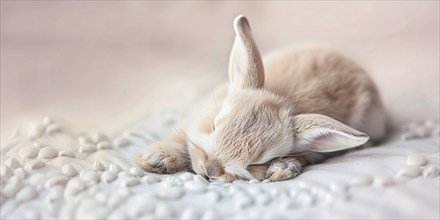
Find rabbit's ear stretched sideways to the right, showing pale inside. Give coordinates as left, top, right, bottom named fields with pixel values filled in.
left=293, top=114, right=369, bottom=152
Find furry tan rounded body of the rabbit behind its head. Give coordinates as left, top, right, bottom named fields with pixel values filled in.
left=264, top=47, right=386, bottom=141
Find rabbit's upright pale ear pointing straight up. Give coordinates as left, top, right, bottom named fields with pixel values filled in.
left=229, top=15, right=264, bottom=89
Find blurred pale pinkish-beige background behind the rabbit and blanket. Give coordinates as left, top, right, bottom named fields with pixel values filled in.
left=1, top=1, right=440, bottom=144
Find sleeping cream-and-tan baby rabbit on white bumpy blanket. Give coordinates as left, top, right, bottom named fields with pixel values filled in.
left=135, top=15, right=385, bottom=182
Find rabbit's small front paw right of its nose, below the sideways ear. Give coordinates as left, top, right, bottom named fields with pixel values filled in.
left=266, top=161, right=302, bottom=182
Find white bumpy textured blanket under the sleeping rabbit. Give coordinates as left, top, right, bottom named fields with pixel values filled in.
left=1, top=115, right=440, bottom=219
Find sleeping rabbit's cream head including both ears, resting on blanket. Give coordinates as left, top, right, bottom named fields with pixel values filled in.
left=189, top=16, right=368, bottom=182
